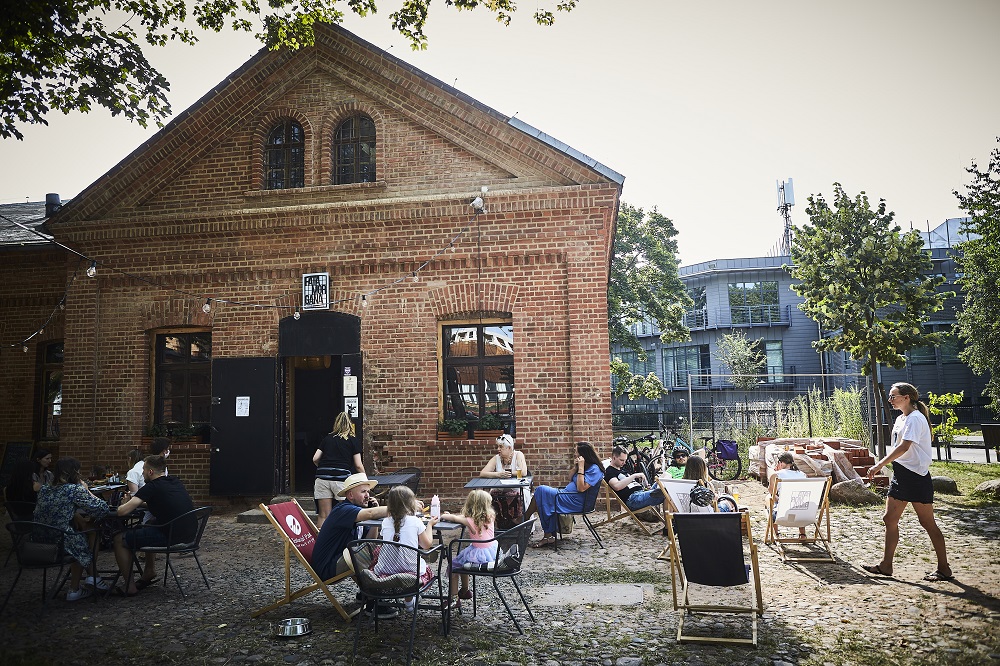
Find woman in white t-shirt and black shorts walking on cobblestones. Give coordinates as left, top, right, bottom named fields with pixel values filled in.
left=862, top=382, right=954, bottom=581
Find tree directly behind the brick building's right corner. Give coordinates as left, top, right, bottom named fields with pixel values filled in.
left=608, top=203, right=693, bottom=399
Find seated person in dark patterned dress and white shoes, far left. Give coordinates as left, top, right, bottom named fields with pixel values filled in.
left=35, top=458, right=112, bottom=601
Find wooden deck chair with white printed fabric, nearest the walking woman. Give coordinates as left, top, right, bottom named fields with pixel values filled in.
left=764, top=476, right=836, bottom=562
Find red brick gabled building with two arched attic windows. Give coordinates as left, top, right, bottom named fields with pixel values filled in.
left=0, top=27, right=623, bottom=498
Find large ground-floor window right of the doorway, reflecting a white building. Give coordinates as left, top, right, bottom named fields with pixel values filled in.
left=441, top=321, right=514, bottom=435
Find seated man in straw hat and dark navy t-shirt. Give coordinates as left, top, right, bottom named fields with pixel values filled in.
left=312, top=473, right=389, bottom=580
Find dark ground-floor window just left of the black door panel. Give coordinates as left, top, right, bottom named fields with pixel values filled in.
left=153, top=331, right=212, bottom=428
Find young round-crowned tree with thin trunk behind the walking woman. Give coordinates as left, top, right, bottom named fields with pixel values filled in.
left=786, top=183, right=950, bottom=455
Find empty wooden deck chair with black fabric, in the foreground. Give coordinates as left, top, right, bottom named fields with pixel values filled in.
left=667, top=513, right=764, bottom=647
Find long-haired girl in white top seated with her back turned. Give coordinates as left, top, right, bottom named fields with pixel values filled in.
left=372, top=486, right=440, bottom=611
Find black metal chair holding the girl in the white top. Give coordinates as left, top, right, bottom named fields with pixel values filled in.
left=347, top=539, right=451, bottom=665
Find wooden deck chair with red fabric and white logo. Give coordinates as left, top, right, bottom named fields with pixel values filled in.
left=250, top=499, right=353, bottom=622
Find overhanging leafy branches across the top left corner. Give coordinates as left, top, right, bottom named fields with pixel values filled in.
left=0, top=0, right=578, bottom=139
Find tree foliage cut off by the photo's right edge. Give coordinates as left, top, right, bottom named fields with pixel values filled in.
left=955, top=139, right=1000, bottom=412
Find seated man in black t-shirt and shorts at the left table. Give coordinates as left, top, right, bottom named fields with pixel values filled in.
left=114, top=455, right=198, bottom=596
